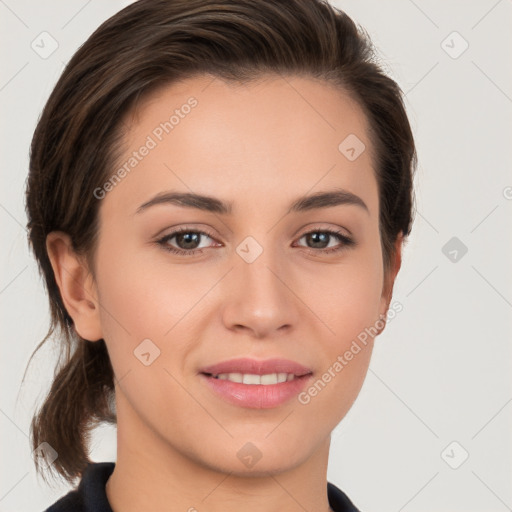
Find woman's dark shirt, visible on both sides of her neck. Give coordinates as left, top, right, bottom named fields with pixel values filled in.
left=44, top=462, right=359, bottom=512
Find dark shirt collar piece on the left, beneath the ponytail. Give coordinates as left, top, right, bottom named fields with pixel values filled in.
left=44, top=462, right=115, bottom=512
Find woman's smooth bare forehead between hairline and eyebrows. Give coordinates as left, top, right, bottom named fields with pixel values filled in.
left=104, top=75, right=376, bottom=219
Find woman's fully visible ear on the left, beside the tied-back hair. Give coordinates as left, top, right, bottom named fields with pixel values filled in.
left=46, top=231, right=103, bottom=341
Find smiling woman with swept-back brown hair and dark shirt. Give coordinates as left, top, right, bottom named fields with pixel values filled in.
left=27, top=0, right=415, bottom=512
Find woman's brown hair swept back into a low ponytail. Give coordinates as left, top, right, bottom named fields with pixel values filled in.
left=26, top=0, right=416, bottom=483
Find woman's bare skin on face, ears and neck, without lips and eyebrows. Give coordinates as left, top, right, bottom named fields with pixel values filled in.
left=47, top=76, right=402, bottom=512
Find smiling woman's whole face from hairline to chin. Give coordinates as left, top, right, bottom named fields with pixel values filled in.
left=76, top=76, right=398, bottom=473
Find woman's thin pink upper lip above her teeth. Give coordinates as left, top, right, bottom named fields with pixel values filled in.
left=200, top=358, right=312, bottom=377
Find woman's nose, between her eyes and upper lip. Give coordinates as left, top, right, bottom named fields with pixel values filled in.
left=222, top=244, right=301, bottom=339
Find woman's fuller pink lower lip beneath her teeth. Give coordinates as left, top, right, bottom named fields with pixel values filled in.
left=200, top=373, right=312, bottom=409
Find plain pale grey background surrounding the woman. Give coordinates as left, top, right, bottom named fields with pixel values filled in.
left=0, top=0, right=512, bottom=512
